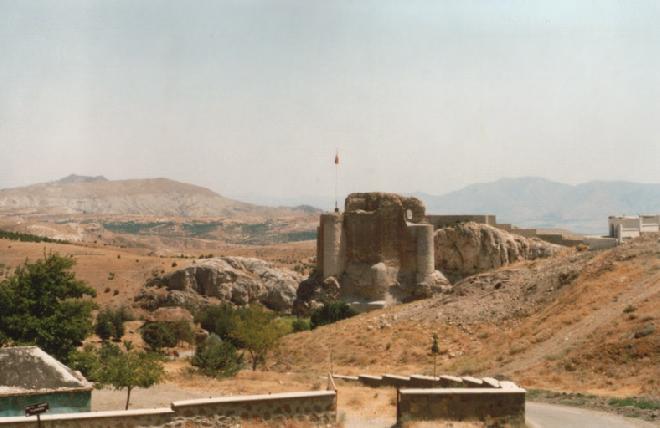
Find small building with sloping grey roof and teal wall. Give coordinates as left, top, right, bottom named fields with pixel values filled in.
left=0, top=346, right=92, bottom=417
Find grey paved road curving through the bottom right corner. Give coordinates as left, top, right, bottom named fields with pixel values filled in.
left=525, top=401, right=660, bottom=428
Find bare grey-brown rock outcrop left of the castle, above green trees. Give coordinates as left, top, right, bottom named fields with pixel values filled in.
left=141, top=257, right=303, bottom=312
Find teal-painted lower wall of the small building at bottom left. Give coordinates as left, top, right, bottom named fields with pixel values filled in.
left=0, top=388, right=92, bottom=417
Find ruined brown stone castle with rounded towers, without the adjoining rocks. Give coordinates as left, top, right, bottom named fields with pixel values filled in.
left=317, top=193, right=447, bottom=303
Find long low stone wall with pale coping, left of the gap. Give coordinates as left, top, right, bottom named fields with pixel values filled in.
left=0, top=391, right=337, bottom=428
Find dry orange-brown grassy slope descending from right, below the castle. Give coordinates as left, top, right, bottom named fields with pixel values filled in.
left=273, top=234, right=660, bottom=396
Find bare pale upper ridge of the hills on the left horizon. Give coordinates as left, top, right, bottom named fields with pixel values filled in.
left=0, top=174, right=314, bottom=218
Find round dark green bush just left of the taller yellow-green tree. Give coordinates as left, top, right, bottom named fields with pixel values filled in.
left=191, top=334, right=243, bottom=377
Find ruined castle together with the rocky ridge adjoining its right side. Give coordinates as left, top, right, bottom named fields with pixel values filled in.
left=294, top=193, right=583, bottom=313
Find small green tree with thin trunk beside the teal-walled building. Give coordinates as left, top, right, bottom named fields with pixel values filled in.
left=78, top=343, right=165, bottom=410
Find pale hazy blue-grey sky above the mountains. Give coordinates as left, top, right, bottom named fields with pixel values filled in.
left=0, top=0, right=660, bottom=209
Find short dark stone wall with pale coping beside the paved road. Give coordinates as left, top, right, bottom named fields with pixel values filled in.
left=397, top=387, right=525, bottom=427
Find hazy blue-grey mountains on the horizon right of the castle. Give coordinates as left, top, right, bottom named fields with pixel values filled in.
left=414, top=177, right=660, bottom=234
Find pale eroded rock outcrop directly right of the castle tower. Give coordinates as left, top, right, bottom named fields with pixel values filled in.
left=434, top=223, right=566, bottom=281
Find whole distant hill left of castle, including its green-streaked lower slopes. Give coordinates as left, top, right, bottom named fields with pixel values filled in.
left=0, top=175, right=320, bottom=247
